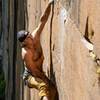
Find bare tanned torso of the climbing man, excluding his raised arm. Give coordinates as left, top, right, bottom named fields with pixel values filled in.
left=22, top=30, right=44, bottom=71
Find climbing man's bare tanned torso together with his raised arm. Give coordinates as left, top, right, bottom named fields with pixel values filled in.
left=22, top=1, right=52, bottom=74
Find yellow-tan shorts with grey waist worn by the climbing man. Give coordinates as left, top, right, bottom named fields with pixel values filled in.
left=23, top=68, right=50, bottom=97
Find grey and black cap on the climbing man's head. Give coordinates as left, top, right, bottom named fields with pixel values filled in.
left=17, top=30, right=29, bottom=42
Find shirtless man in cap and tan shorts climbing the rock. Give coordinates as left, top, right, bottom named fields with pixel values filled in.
left=17, top=0, right=57, bottom=100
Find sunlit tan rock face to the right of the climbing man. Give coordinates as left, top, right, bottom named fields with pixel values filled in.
left=23, top=0, right=100, bottom=100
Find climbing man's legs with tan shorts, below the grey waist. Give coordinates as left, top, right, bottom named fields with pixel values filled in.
left=26, top=75, right=56, bottom=100
